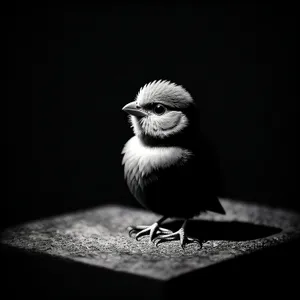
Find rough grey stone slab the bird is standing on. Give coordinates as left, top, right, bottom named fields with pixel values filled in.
left=1, top=199, right=300, bottom=298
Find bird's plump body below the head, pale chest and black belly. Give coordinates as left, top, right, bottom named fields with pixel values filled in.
left=123, top=136, right=224, bottom=218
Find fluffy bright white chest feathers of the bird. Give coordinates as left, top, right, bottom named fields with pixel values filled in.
left=122, top=136, right=191, bottom=190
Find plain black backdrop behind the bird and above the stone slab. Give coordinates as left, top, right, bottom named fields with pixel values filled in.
left=1, top=1, right=298, bottom=230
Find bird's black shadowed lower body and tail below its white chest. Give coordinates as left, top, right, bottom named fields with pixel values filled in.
left=142, top=146, right=225, bottom=218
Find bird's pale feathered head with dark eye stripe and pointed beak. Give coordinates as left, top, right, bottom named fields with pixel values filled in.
left=123, top=80, right=195, bottom=140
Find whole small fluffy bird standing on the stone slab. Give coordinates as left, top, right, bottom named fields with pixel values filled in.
left=122, top=80, right=225, bottom=249
